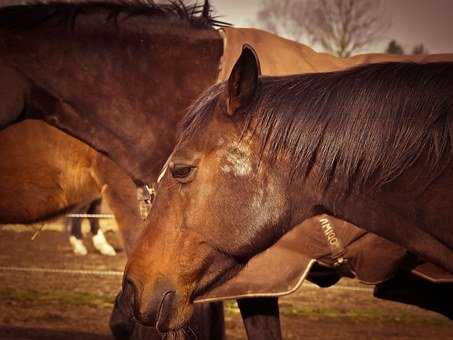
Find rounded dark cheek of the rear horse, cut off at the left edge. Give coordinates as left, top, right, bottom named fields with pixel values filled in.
left=0, top=64, right=29, bottom=129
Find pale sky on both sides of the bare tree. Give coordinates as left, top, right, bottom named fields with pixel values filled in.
left=211, top=0, right=453, bottom=53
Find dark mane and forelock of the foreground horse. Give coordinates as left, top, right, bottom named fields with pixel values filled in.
left=181, top=63, right=453, bottom=190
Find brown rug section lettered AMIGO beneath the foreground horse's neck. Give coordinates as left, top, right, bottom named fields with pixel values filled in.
left=197, top=215, right=453, bottom=302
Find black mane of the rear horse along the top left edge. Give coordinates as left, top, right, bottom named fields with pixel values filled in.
left=0, top=0, right=229, bottom=29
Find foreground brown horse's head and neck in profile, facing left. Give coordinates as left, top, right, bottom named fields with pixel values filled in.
left=119, top=46, right=453, bottom=332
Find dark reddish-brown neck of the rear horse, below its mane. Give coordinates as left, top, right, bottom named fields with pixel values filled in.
left=0, top=16, right=222, bottom=183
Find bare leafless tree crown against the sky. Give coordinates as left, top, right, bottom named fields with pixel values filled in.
left=257, top=0, right=387, bottom=57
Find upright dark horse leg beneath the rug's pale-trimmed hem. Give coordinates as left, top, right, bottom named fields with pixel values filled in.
left=237, top=297, right=282, bottom=340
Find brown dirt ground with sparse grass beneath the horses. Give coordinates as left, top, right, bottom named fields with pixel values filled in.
left=0, top=223, right=453, bottom=340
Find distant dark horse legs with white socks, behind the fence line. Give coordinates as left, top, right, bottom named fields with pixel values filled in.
left=66, top=198, right=116, bottom=256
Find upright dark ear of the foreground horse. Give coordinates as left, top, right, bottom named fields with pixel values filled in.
left=227, top=45, right=261, bottom=116
